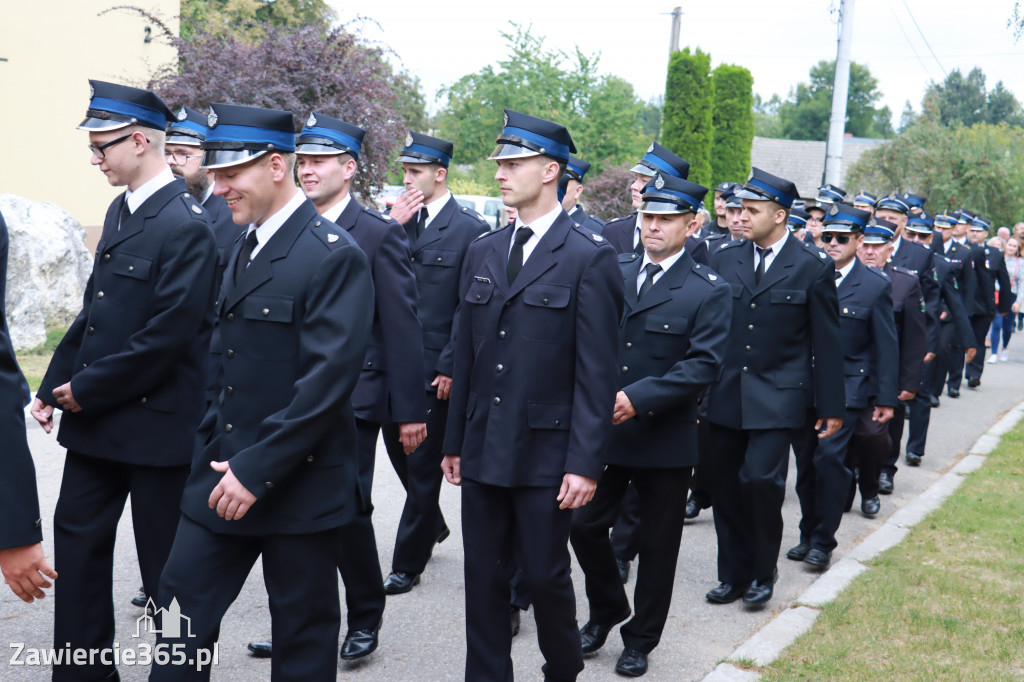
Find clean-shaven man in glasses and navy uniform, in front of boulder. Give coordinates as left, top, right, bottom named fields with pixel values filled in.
left=32, top=81, right=216, bottom=680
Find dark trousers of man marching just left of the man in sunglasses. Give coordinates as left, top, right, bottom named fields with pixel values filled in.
left=708, top=423, right=801, bottom=586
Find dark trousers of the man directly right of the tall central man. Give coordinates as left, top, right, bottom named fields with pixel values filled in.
left=569, top=464, right=691, bottom=653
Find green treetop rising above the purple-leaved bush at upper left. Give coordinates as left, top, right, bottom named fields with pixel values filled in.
left=181, top=0, right=336, bottom=42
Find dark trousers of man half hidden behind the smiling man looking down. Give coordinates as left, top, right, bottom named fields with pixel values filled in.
left=337, top=418, right=387, bottom=631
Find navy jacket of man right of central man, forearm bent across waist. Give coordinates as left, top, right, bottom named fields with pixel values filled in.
left=605, top=252, right=732, bottom=469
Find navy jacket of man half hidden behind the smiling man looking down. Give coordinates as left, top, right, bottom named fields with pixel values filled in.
left=338, top=199, right=427, bottom=424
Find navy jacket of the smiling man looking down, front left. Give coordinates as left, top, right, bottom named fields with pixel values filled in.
left=181, top=200, right=374, bottom=535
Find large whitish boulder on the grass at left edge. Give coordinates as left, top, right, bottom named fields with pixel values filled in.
left=0, top=195, right=92, bottom=350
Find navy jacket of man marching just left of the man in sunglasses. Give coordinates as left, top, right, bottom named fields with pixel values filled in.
left=708, top=237, right=846, bottom=430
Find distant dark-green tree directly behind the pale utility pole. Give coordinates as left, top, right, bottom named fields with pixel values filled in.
left=778, top=60, right=893, bottom=140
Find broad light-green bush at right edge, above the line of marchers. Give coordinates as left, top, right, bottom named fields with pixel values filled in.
left=847, top=119, right=1024, bottom=225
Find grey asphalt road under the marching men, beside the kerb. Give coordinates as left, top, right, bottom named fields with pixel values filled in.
left=0, top=352, right=1024, bottom=682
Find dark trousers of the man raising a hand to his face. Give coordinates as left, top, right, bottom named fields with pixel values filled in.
left=381, top=392, right=449, bottom=576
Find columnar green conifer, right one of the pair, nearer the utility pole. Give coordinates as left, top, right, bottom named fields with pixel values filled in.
left=711, top=63, right=754, bottom=186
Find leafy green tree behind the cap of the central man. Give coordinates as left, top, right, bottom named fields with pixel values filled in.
left=436, top=24, right=646, bottom=178
